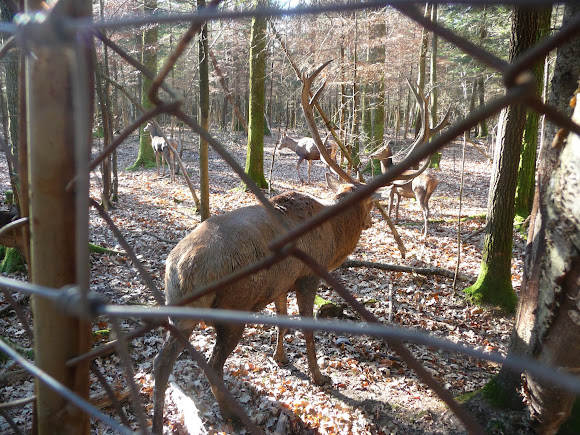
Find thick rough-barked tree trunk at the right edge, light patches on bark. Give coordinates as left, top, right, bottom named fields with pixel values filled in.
left=496, top=5, right=580, bottom=433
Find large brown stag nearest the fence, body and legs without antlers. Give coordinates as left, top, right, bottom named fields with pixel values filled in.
left=153, top=174, right=372, bottom=433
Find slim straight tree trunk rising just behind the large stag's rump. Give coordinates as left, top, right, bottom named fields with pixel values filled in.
left=197, top=0, right=210, bottom=221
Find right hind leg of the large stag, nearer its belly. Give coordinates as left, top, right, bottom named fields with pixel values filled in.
left=209, top=324, right=244, bottom=420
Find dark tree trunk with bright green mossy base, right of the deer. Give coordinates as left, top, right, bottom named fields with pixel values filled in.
left=464, top=7, right=538, bottom=312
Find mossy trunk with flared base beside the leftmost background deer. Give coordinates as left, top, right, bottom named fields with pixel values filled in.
left=127, top=0, right=159, bottom=170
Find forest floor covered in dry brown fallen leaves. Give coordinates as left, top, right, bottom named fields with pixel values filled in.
left=0, top=127, right=527, bottom=434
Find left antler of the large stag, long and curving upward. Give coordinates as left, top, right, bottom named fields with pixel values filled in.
left=300, top=59, right=356, bottom=183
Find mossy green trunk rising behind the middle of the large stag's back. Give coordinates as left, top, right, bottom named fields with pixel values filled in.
left=246, top=0, right=268, bottom=189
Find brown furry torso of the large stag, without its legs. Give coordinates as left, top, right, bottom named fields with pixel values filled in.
left=165, top=188, right=370, bottom=310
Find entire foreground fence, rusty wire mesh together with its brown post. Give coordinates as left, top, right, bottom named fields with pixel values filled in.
left=0, top=0, right=580, bottom=433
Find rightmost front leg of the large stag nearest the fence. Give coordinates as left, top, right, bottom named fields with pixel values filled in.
left=296, top=277, right=331, bottom=385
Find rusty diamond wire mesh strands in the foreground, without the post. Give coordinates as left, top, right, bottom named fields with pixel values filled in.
left=0, top=0, right=580, bottom=433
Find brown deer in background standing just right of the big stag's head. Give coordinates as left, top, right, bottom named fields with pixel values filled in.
left=370, top=141, right=439, bottom=237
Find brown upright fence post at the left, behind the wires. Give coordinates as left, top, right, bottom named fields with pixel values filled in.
left=25, top=0, right=93, bottom=434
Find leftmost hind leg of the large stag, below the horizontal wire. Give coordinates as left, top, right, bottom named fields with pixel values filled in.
left=152, top=326, right=193, bottom=434
